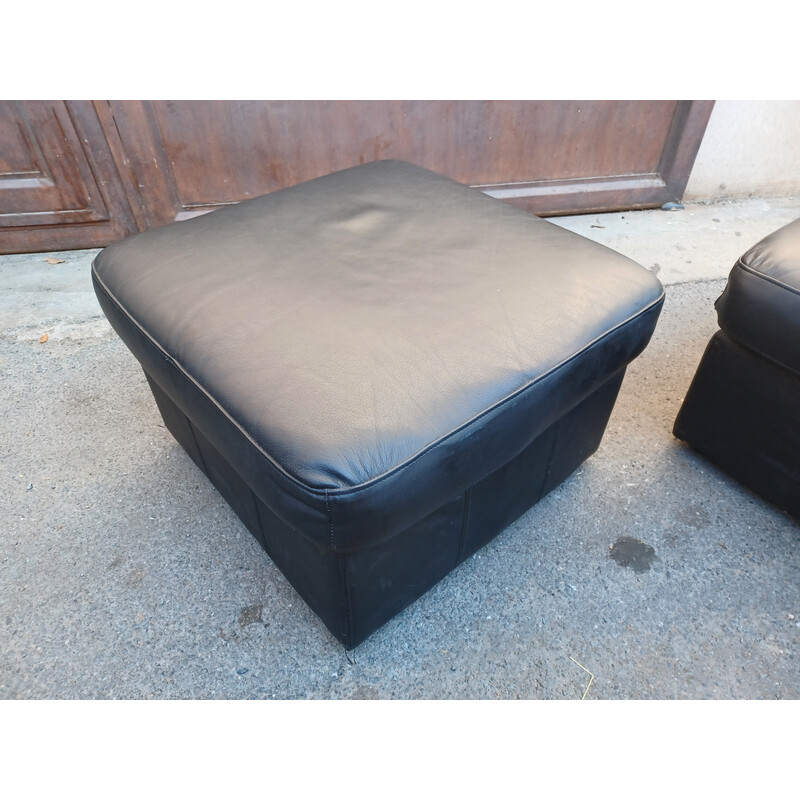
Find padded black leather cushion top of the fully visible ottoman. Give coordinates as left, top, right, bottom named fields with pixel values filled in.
left=93, top=161, right=663, bottom=548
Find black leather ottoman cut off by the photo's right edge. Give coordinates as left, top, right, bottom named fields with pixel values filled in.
left=674, top=220, right=800, bottom=519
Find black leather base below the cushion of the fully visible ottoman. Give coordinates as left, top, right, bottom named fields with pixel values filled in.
left=150, top=360, right=624, bottom=648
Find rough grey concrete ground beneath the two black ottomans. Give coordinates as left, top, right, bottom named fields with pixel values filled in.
left=0, top=198, right=800, bottom=700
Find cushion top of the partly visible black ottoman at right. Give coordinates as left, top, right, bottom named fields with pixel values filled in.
left=716, top=220, right=800, bottom=375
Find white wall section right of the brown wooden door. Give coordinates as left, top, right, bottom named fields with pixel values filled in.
left=683, top=100, right=800, bottom=202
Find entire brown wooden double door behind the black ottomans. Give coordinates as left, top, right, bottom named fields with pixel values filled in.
left=0, top=100, right=713, bottom=253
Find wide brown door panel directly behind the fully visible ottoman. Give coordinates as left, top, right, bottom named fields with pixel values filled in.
left=111, top=100, right=713, bottom=225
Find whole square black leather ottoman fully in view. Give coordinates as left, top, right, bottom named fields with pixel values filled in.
left=92, top=161, right=663, bottom=648
